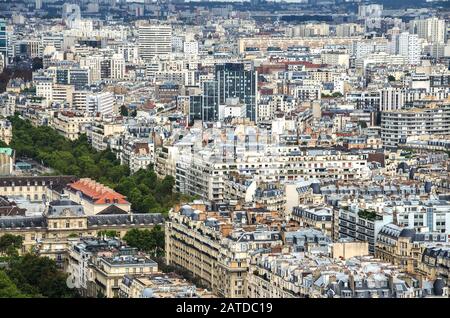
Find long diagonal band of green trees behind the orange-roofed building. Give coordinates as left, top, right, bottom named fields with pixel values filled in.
left=9, top=115, right=190, bottom=214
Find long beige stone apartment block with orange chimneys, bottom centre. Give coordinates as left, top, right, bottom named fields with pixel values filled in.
left=165, top=201, right=281, bottom=298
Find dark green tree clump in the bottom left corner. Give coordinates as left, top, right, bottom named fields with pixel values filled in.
left=0, top=234, right=78, bottom=298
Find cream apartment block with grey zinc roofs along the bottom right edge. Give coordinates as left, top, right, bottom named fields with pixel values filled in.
left=248, top=253, right=440, bottom=298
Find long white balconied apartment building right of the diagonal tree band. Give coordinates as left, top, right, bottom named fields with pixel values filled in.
left=175, top=147, right=369, bottom=200
